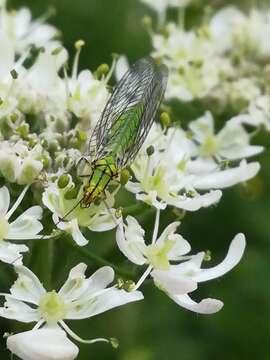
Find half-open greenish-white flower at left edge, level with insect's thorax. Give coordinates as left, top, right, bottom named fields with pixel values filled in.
left=0, top=141, right=43, bottom=185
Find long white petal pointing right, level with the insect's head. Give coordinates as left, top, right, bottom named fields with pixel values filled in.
left=193, top=160, right=260, bottom=190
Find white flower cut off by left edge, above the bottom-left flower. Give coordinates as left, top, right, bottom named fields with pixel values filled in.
left=0, top=186, right=43, bottom=264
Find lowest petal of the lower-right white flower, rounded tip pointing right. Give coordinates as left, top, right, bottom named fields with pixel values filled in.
left=169, top=294, right=223, bottom=314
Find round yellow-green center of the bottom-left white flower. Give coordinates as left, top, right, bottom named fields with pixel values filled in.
left=39, top=290, right=67, bottom=324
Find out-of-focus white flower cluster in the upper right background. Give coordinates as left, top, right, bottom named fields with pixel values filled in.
left=147, top=4, right=270, bottom=120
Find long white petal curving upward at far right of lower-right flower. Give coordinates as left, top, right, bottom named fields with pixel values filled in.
left=193, top=234, right=246, bottom=282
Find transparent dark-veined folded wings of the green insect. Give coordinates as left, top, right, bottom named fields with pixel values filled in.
left=89, top=57, right=168, bottom=167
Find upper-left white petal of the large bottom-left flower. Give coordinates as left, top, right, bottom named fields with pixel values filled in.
left=10, top=266, right=46, bottom=304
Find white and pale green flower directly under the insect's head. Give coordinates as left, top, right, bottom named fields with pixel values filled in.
left=42, top=177, right=117, bottom=246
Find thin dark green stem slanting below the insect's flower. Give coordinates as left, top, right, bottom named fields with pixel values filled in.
left=67, top=238, right=134, bottom=280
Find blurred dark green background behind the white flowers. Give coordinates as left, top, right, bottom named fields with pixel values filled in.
left=0, top=0, right=270, bottom=360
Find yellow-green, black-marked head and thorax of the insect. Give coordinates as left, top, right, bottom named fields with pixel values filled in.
left=81, top=156, right=118, bottom=207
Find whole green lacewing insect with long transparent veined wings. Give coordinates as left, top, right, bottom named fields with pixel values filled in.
left=80, top=57, right=168, bottom=207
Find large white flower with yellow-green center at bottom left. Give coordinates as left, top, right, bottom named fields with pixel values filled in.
left=0, top=263, right=143, bottom=360
